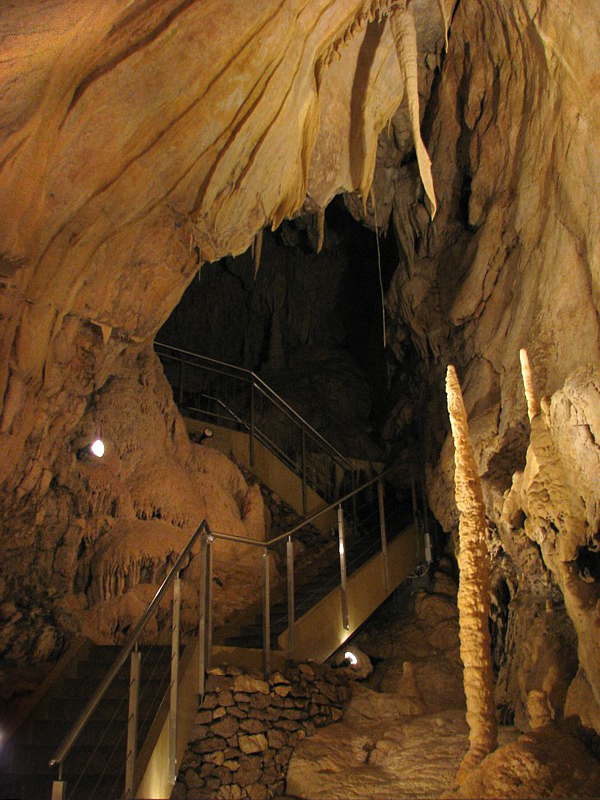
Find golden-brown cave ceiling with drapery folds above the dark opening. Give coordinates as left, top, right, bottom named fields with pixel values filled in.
left=0, top=0, right=450, bottom=477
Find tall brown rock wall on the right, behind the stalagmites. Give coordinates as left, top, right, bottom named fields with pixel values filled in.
left=375, top=0, right=600, bottom=736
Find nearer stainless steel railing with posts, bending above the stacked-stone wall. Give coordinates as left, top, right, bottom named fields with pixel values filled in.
left=50, top=466, right=424, bottom=800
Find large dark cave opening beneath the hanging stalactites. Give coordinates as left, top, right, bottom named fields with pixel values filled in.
left=156, top=196, right=419, bottom=460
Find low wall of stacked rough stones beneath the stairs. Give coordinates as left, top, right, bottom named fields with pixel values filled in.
left=172, top=664, right=350, bottom=800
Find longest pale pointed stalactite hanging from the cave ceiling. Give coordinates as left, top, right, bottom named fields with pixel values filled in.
left=390, top=6, right=437, bottom=219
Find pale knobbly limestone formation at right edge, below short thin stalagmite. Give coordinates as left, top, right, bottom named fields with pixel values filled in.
left=510, top=356, right=600, bottom=720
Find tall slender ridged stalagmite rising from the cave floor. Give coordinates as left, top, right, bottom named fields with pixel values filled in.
left=446, top=366, right=497, bottom=783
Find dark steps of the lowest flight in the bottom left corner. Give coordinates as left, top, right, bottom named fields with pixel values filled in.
left=0, top=640, right=171, bottom=800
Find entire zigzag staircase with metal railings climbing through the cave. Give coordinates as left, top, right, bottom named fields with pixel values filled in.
left=0, top=346, right=422, bottom=800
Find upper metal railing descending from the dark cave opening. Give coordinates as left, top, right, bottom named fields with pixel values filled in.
left=155, top=342, right=358, bottom=514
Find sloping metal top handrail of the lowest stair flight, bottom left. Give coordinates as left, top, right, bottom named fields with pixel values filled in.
left=49, top=519, right=212, bottom=767
